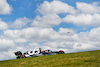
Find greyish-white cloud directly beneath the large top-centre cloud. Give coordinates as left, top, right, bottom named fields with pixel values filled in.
left=32, top=14, right=62, bottom=28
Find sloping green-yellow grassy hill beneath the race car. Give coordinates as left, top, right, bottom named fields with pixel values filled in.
left=0, top=50, right=100, bottom=67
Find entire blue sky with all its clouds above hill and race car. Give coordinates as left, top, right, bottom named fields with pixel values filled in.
left=0, top=0, right=100, bottom=60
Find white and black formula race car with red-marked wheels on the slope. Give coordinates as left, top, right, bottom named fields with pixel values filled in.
left=14, top=48, right=65, bottom=58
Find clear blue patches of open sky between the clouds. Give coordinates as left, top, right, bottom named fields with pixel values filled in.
left=0, top=0, right=99, bottom=32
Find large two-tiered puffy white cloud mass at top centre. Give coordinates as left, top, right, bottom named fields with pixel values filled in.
left=32, top=1, right=77, bottom=27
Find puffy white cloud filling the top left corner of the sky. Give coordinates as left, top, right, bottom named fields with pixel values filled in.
left=0, top=0, right=12, bottom=15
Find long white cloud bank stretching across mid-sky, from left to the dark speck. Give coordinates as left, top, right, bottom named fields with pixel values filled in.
left=4, top=27, right=75, bottom=43
